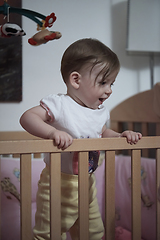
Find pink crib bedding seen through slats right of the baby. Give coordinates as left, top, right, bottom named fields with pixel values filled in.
left=96, top=155, right=157, bottom=240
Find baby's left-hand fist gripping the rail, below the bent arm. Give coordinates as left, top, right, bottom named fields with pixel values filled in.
left=49, top=129, right=73, bottom=150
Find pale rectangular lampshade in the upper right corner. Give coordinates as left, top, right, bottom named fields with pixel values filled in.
left=127, top=0, right=160, bottom=52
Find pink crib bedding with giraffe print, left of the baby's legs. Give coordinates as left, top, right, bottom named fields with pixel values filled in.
left=1, top=157, right=45, bottom=240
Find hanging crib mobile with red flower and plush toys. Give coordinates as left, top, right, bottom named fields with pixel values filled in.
left=0, top=0, right=62, bottom=46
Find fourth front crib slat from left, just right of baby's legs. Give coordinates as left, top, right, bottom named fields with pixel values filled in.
left=105, top=151, right=115, bottom=240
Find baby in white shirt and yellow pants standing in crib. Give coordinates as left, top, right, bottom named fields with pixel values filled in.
left=20, top=39, right=142, bottom=240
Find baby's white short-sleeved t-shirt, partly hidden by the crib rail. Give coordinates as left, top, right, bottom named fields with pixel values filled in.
left=40, top=94, right=109, bottom=174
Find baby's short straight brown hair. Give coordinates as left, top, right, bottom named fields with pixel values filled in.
left=61, top=38, right=120, bottom=83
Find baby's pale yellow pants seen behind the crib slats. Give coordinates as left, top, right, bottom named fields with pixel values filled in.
left=33, top=168, right=104, bottom=240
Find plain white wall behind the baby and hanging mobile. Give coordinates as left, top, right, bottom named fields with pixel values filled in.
left=0, top=0, right=160, bottom=131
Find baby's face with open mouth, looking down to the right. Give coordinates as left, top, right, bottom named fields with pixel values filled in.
left=74, top=64, right=118, bottom=109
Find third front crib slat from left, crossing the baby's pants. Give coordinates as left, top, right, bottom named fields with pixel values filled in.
left=78, top=152, right=89, bottom=240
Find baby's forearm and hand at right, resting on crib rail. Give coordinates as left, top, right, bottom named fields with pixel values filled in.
left=102, top=126, right=142, bottom=144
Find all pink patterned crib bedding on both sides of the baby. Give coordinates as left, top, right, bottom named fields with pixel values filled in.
left=1, top=155, right=160, bottom=240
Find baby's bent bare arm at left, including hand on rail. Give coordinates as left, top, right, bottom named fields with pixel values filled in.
left=20, top=106, right=73, bottom=150
